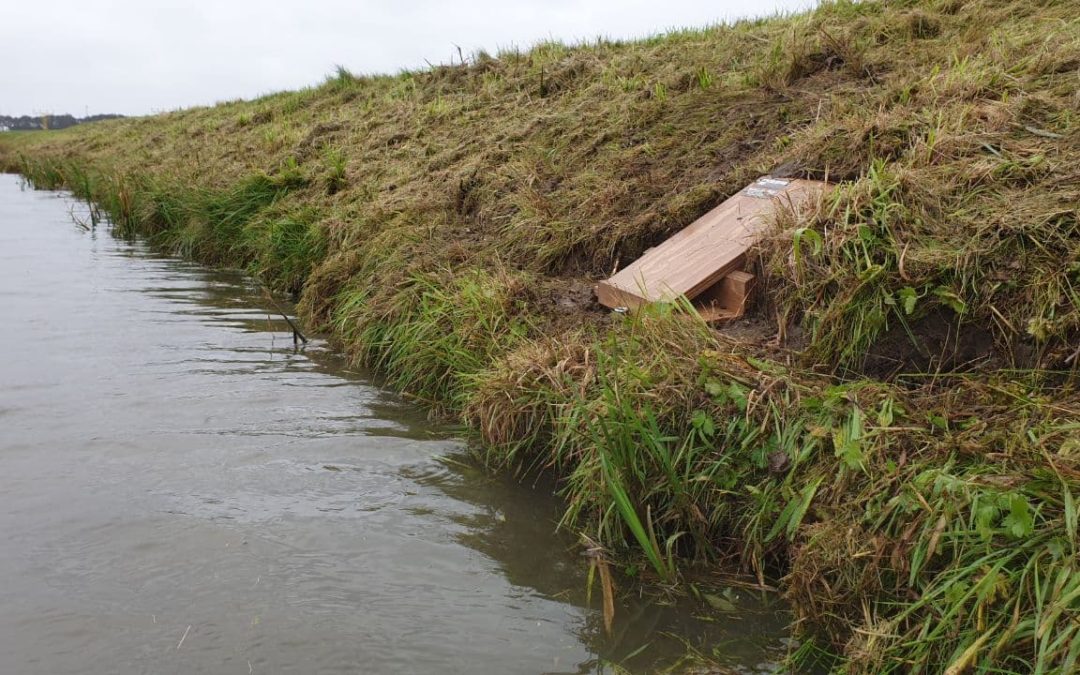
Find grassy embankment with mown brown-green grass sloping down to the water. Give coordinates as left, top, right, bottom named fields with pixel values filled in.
left=0, top=0, right=1080, bottom=672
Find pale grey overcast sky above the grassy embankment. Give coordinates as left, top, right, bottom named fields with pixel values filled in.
left=0, top=0, right=814, bottom=117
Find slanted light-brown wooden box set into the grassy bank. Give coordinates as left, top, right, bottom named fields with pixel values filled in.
left=596, top=176, right=828, bottom=321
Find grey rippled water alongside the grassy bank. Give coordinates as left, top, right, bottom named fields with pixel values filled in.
left=0, top=175, right=785, bottom=675
